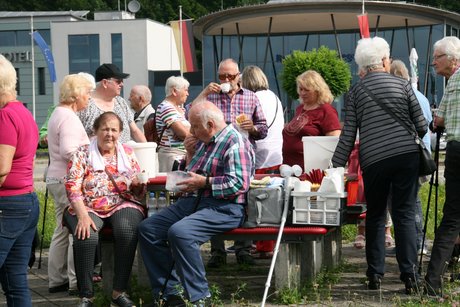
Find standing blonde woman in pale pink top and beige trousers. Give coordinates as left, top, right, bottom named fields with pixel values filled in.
left=46, top=74, right=95, bottom=293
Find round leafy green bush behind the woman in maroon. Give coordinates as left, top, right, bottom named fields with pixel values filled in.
left=280, top=46, right=351, bottom=99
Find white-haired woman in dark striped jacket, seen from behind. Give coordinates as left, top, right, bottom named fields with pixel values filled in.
left=332, top=37, right=427, bottom=294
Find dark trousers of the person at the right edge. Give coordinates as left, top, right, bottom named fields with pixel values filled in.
left=425, top=141, right=460, bottom=291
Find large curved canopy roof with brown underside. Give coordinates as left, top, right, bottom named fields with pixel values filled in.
left=194, top=0, right=460, bottom=39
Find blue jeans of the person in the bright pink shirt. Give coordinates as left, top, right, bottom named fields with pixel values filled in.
left=0, top=193, right=40, bottom=307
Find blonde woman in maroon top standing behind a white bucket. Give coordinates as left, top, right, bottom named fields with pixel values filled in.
left=283, top=70, right=341, bottom=168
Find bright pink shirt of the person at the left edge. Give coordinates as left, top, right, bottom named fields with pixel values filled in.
left=0, top=101, right=38, bottom=196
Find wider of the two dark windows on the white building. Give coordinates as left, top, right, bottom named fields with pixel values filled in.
left=69, top=34, right=100, bottom=74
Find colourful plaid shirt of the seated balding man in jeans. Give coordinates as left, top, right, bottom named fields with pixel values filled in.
left=187, top=126, right=255, bottom=204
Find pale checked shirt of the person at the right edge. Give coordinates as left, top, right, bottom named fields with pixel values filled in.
left=436, top=68, right=460, bottom=142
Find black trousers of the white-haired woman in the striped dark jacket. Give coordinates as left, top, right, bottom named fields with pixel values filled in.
left=363, top=152, right=419, bottom=281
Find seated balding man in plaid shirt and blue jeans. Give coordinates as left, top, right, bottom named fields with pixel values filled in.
left=139, top=101, right=255, bottom=307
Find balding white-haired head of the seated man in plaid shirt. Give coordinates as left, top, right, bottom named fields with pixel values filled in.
left=189, top=100, right=227, bottom=143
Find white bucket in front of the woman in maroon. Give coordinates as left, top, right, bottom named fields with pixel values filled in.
left=302, top=136, right=339, bottom=173
